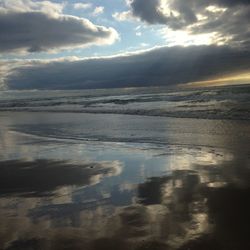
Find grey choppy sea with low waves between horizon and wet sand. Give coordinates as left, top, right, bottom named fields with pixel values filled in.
left=0, top=86, right=250, bottom=120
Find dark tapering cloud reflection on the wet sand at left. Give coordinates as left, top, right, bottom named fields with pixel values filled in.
left=0, top=160, right=122, bottom=196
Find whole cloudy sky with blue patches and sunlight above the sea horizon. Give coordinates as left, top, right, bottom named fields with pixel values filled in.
left=0, top=0, right=250, bottom=90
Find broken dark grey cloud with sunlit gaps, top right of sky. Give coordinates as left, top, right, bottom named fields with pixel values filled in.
left=118, top=0, right=250, bottom=47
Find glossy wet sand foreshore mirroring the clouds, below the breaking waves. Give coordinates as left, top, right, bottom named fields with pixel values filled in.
left=0, top=112, right=250, bottom=250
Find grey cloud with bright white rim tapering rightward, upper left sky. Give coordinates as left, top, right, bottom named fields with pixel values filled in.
left=0, top=0, right=119, bottom=53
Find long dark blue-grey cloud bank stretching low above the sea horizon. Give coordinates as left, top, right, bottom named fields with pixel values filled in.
left=2, top=46, right=250, bottom=89
